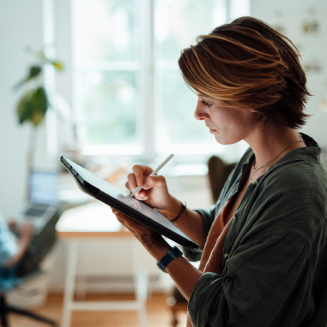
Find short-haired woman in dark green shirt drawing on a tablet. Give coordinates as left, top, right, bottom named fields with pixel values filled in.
left=113, top=17, right=327, bottom=327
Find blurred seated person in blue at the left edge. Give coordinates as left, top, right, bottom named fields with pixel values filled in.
left=0, top=215, right=33, bottom=291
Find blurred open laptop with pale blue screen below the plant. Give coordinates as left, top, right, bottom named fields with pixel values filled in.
left=20, top=170, right=58, bottom=235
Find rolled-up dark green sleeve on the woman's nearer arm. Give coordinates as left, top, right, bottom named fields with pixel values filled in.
left=188, top=233, right=308, bottom=327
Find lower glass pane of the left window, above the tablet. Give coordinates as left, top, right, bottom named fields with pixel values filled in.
left=77, top=71, right=139, bottom=145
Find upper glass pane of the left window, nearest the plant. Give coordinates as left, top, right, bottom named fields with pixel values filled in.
left=76, top=0, right=140, bottom=61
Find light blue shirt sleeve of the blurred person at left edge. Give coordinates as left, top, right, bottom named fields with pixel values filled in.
left=0, top=216, right=18, bottom=266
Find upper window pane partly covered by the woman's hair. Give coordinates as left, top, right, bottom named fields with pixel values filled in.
left=155, top=0, right=226, bottom=60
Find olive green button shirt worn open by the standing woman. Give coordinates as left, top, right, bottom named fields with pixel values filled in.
left=184, top=133, right=327, bottom=327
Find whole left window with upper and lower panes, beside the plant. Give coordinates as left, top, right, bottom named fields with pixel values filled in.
left=74, top=0, right=142, bottom=153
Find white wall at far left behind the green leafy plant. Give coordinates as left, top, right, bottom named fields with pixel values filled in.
left=0, top=0, right=45, bottom=217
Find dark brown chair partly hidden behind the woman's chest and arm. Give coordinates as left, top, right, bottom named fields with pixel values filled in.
left=166, top=156, right=236, bottom=327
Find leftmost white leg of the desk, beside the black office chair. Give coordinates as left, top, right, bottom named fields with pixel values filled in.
left=61, top=240, right=78, bottom=327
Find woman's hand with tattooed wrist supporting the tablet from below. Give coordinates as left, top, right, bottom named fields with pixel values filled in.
left=111, top=208, right=167, bottom=254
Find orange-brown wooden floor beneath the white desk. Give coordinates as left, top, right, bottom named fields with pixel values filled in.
left=9, top=294, right=186, bottom=327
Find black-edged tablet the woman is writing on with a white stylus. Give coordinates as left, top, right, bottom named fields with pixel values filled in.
left=59, top=157, right=198, bottom=251
